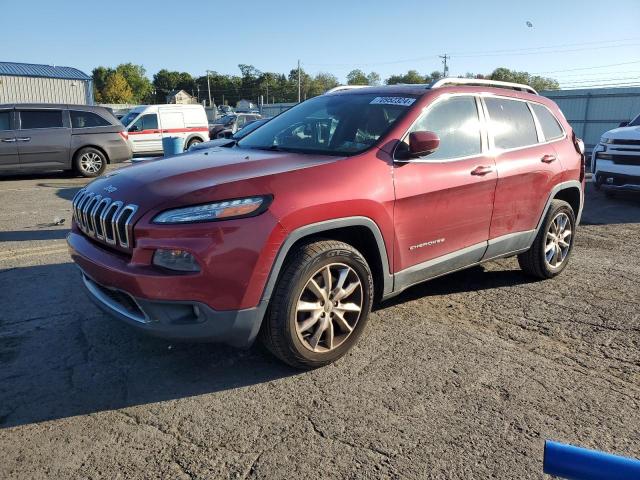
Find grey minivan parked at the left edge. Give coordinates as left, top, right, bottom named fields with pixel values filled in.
left=0, top=103, right=131, bottom=177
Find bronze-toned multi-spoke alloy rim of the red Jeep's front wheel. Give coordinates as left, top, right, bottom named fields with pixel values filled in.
left=296, top=263, right=363, bottom=352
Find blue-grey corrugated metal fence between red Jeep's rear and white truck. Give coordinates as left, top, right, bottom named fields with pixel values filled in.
left=540, top=87, right=640, bottom=151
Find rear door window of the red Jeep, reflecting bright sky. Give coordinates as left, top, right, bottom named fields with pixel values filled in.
left=485, top=98, right=538, bottom=148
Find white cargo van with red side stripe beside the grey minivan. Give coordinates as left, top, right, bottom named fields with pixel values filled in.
left=121, top=105, right=209, bottom=154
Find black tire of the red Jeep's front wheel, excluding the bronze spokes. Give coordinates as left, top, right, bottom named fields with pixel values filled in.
left=260, top=240, right=373, bottom=369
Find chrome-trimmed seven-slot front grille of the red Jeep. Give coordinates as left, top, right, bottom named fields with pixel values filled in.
left=72, top=189, right=138, bottom=249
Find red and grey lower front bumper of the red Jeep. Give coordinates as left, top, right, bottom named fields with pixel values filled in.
left=67, top=231, right=267, bottom=348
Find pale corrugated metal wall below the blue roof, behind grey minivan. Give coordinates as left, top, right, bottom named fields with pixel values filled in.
left=0, top=75, right=90, bottom=105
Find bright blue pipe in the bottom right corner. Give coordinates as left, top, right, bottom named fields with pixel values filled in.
left=543, top=440, right=640, bottom=480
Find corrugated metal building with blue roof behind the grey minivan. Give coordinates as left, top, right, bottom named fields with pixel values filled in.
left=0, top=62, right=93, bottom=105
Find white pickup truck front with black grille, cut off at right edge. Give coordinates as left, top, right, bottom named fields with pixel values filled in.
left=591, top=115, right=640, bottom=192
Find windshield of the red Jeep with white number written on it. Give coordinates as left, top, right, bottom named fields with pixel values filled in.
left=238, top=94, right=417, bottom=155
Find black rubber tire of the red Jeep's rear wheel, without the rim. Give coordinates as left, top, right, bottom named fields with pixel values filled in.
left=518, top=200, right=576, bottom=279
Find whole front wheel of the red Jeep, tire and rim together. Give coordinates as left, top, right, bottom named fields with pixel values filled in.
left=261, top=240, right=373, bottom=368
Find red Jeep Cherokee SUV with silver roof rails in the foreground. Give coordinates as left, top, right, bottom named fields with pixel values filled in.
left=68, top=79, right=584, bottom=368
